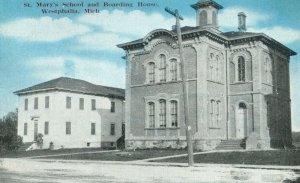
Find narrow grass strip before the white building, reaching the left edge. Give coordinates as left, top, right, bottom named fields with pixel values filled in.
left=0, top=148, right=104, bottom=158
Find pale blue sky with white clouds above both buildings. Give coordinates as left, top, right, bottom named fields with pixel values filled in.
left=0, top=0, right=300, bottom=131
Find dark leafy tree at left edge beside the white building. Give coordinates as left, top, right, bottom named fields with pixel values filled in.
left=0, top=109, right=23, bottom=151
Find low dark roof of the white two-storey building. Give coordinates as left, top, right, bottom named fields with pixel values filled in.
left=14, top=77, right=125, bottom=99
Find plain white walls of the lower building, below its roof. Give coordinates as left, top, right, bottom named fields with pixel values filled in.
left=18, top=91, right=124, bottom=148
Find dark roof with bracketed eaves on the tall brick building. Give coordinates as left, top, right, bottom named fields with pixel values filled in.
left=117, top=26, right=297, bottom=56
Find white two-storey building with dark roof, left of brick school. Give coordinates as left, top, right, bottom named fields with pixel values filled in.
left=15, top=77, right=125, bottom=149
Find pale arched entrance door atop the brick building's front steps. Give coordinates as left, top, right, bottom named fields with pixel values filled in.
left=236, top=103, right=247, bottom=139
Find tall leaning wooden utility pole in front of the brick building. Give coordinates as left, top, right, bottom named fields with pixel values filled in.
left=165, top=8, right=194, bottom=166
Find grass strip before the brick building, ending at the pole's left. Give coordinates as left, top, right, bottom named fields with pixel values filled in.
left=39, top=149, right=187, bottom=161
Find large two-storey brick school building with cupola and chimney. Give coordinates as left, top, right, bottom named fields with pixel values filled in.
left=118, top=0, right=296, bottom=150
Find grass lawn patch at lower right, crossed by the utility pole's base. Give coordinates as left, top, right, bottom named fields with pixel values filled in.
left=154, top=149, right=300, bottom=166
